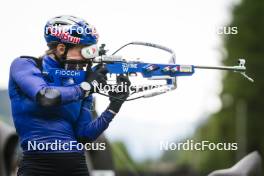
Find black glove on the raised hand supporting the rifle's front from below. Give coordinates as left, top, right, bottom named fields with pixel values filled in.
left=108, top=75, right=131, bottom=113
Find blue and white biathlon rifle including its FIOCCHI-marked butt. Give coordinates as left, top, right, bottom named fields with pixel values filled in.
left=45, top=42, right=254, bottom=101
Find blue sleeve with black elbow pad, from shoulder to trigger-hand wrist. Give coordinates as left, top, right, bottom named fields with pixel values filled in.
left=10, top=58, right=83, bottom=104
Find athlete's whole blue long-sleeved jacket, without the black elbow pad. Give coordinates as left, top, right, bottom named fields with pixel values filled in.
left=9, top=56, right=114, bottom=152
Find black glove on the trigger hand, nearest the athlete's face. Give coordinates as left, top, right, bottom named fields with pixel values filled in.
left=86, top=66, right=108, bottom=94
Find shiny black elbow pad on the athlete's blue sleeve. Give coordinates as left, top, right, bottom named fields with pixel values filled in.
left=36, top=88, right=61, bottom=107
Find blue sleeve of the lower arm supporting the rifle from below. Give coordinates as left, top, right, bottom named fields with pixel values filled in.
left=75, top=96, right=114, bottom=142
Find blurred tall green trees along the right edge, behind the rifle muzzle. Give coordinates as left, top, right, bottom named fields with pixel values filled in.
left=159, top=0, right=264, bottom=175
